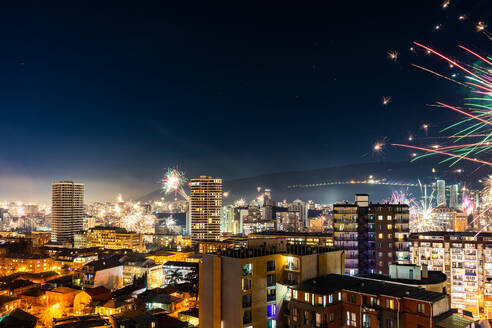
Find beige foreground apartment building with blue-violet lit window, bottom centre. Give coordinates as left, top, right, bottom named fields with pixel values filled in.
left=199, top=245, right=344, bottom=328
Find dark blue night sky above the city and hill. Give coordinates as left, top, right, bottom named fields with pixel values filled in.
left=0, top=0, right=492, bottom=200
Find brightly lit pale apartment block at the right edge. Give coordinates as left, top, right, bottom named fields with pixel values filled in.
left=411, top=232, right=492, bottom=318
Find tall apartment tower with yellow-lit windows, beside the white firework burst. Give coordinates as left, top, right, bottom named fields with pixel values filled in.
left=190, top=175, right=222, bottom=245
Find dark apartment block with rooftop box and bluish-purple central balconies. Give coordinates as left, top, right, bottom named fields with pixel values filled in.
left=333, top=194, right=410, bottom=276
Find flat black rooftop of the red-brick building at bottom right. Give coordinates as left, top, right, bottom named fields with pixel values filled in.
left=293, top=274, right=446, bottom=302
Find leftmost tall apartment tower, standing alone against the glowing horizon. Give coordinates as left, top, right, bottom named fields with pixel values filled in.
left=51, top=181, right=84, bottom=242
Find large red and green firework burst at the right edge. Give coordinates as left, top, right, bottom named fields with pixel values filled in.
left=392, top=42, right=492, bottom=166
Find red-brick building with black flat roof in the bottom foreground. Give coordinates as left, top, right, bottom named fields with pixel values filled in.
left=283, top=274, right=450, bottom=328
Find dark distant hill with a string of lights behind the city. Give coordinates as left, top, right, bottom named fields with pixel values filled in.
left=139, top=160, right=491, bottom=204
